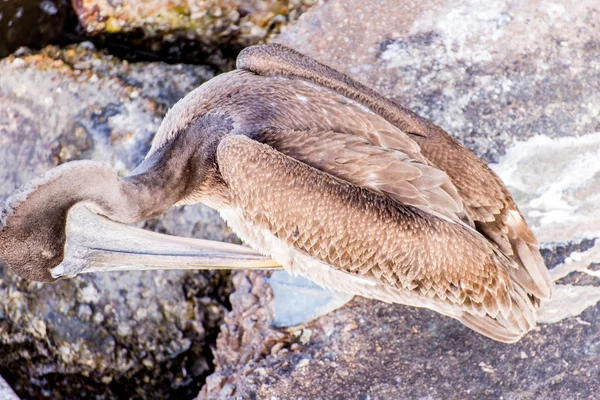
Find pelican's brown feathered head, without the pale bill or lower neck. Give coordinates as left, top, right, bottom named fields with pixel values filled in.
left=0, top=161, right=127, bottom=281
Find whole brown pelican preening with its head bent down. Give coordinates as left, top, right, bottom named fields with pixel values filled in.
left=0, top=44, right=552, bottom=342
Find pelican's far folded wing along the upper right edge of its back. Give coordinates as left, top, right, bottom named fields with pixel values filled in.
left=237, top=44, right=552, bottom=299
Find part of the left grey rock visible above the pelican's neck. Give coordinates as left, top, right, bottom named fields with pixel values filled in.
left=0, top=44, right=212, bottom=194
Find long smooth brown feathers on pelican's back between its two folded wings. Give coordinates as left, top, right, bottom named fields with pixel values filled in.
left=257, top=129, right=464, bottom=221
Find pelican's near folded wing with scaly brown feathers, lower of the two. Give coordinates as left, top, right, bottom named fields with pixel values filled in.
left=217, top=136, right=535, bottom=341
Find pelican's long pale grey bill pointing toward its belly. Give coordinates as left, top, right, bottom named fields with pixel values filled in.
left=50, top=205, right=282, bottom=279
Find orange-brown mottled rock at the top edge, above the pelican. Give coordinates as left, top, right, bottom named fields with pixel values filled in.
left=72, top=0, right=319, bottom=66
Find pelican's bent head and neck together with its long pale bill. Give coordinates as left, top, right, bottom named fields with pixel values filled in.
left=0, top=108, right=277, bottom=282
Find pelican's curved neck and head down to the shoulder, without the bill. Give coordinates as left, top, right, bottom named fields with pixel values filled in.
left=0, top=112, right=228, bottom=281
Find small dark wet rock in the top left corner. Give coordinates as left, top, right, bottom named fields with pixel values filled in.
left=0, top=0, right=67, bottom=57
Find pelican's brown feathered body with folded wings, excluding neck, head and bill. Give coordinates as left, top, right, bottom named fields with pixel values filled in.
left=151, top=45, right=551, bottom=342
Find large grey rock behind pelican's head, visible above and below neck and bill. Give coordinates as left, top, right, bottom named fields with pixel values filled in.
left=0, top=43, right=231, bottom=398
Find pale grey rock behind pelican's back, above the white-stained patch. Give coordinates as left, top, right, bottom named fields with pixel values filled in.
left=277, top=0, right=600, bottom=162
